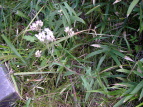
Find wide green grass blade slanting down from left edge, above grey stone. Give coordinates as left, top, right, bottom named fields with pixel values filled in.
left=1, top=35, right=26, bottom=64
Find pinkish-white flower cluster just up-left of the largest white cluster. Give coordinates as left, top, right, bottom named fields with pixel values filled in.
left=30, top=20, right=43, bottom=31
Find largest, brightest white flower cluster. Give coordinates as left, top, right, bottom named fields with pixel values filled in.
left=35, top=28, right=56, bottom=42
